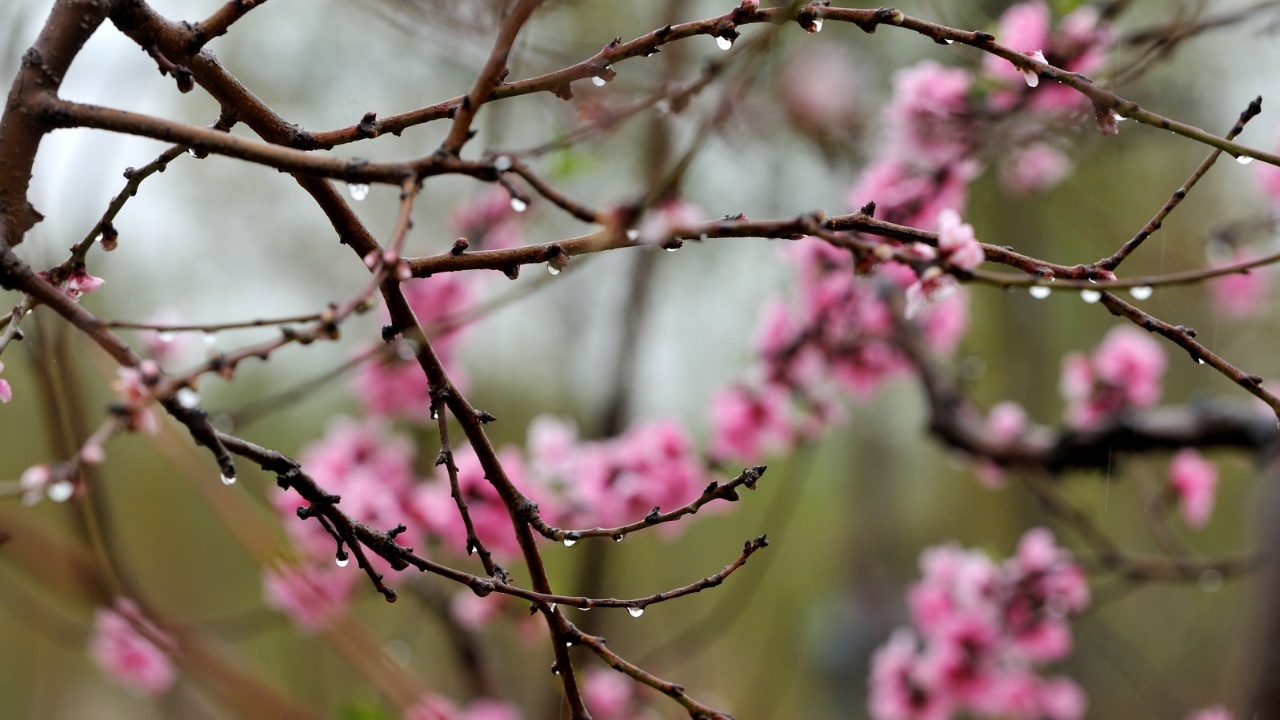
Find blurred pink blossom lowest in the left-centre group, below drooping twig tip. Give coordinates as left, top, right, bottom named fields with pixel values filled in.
left=262, top=564, right=361, bottom=633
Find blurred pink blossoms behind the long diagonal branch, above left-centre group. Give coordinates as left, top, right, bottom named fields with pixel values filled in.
left=355, top=273, right=474, bottom=421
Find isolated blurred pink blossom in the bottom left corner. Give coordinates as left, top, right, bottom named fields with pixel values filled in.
left=88, top=598, right=175, bottom=696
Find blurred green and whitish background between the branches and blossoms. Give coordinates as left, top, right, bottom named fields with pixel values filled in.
left=0, top=0, right=1280, bottom=719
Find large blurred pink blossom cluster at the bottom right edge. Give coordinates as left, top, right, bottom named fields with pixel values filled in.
left=868, top=528, right=1089, bottom=720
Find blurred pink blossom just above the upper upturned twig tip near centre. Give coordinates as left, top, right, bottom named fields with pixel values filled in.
left=710, top=384, right=794, bottom=462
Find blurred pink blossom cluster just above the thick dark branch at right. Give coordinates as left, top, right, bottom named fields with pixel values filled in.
left=1059, top=325, right=1167, bottom=429
